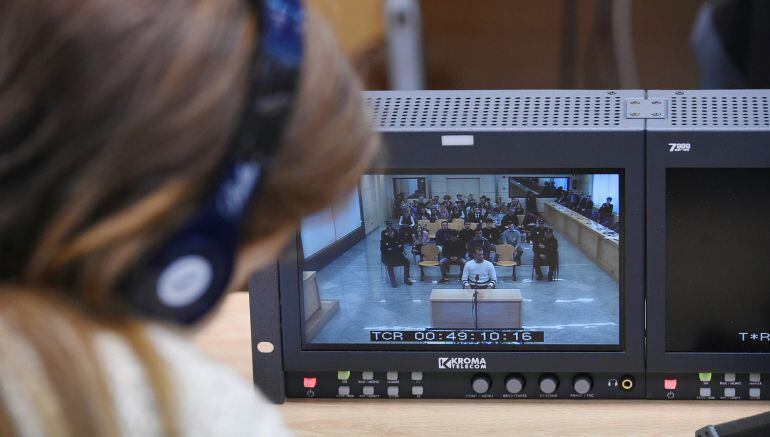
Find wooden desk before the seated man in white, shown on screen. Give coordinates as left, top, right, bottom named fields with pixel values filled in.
left=430, top=288, right=522, bottom=329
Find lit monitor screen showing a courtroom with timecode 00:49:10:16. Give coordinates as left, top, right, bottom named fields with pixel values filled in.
left=298, top=169, right=623, bottom=351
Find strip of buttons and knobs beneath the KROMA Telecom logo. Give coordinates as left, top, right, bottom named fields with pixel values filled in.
left=286, top=370, right=644, bottom=399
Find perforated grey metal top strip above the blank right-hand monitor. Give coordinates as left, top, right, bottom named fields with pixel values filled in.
left=648, top=90, right=770, bottom=130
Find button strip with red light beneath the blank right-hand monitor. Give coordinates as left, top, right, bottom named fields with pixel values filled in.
left=647, top=371, right=770, bottom=400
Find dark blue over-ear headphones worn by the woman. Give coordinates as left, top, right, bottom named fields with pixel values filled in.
left=124, top=0, right=304, bottom=324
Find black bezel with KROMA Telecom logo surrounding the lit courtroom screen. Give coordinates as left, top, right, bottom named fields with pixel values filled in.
left=279, top=128, right=644, bottom=371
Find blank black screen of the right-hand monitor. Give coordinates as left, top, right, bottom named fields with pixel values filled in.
left=666, top=168, right=770, bottom=352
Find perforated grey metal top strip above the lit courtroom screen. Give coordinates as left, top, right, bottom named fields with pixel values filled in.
left=364, top=91, right=641, bottom=131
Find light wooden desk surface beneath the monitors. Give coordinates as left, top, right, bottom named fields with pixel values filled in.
left=193, top=293, right=770, bottom=436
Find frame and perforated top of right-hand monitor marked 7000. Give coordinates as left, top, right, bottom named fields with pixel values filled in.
left=646, top=90, right=770, bottom=374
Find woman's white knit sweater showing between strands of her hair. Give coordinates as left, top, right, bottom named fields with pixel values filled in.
left=0, top=325, right=290, bottom=437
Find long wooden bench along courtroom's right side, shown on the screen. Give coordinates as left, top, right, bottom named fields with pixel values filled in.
left=543, top=201, right=620, bottom=281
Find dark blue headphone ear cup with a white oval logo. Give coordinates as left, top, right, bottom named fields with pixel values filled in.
left=131, top=231, right=235, bottom=324
